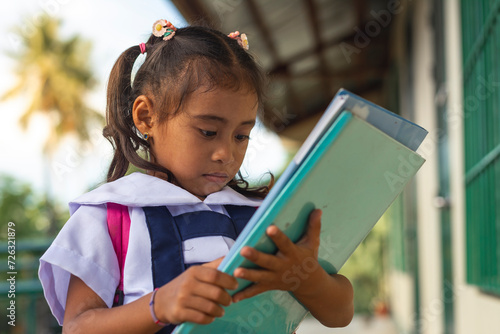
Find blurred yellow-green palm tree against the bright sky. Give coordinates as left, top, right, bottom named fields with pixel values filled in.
left=1, top=15, right=103, bottom=234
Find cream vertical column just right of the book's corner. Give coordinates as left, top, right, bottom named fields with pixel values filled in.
left=413, top=0, right=444, bottom=334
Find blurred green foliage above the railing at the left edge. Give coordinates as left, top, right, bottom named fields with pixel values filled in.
left=0, top=175, right=69, bottom=240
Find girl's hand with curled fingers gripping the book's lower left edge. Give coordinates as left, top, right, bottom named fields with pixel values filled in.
left=154, top=258, right=238, bottom=324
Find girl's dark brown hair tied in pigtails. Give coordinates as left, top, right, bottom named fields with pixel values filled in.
left=103, top=26, right=274, bottom=198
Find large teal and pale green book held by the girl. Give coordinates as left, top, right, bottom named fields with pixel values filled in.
left=174, top=89, right=427, bottom=334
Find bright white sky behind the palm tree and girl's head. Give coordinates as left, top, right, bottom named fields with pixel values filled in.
left=0, top=0, right=286, bottom=202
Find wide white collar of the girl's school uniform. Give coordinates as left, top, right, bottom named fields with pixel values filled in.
left=69, top=172, right=262, bottom=214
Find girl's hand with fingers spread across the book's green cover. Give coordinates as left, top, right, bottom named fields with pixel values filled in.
left=233, top=210, right=327, bottom=302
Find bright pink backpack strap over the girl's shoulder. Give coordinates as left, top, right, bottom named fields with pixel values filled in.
left=107, top=203, right=130, bottom=306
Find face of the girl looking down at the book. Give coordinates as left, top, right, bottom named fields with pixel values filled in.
left=151, top=88, right=258, bottom=199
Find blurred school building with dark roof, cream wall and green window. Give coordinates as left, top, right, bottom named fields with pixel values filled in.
left=173, top=0, right=500, bottom=334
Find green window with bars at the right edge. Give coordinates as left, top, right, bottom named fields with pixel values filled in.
left=461, top=0, right=500, bottom=294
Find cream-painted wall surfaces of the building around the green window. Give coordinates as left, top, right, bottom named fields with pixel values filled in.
left=390, top=0, right=500, bottom=334
